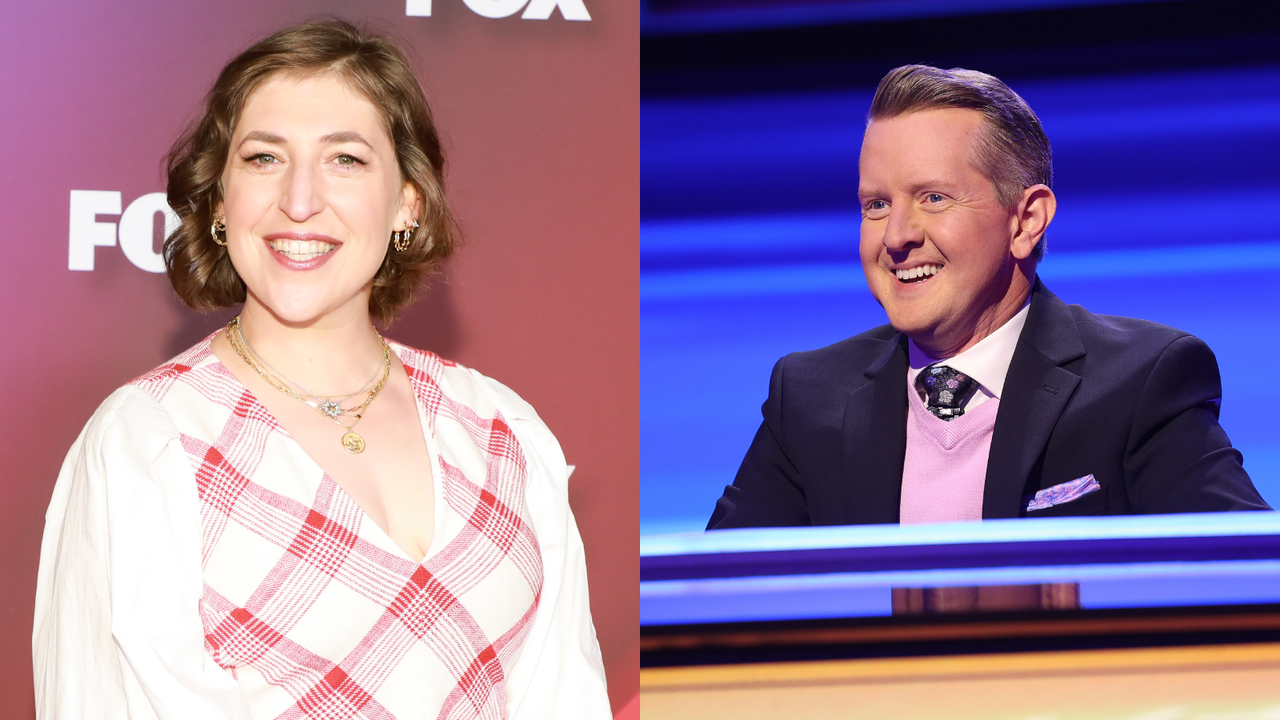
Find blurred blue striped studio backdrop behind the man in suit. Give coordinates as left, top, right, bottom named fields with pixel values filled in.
left=641, top=0, right=1280, bottom=534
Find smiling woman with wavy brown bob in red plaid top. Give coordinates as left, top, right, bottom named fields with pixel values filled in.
left=33, top=22, right=609, bottom=719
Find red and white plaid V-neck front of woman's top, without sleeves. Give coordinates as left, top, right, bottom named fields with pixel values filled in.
left=132, top=338, right=543, bottom=720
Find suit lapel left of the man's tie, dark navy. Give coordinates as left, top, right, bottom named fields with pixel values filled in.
left=841, top=333, right=908, bottom=524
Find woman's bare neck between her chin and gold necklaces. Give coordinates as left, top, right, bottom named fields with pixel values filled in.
left=239, top=296, right=383, bottom=395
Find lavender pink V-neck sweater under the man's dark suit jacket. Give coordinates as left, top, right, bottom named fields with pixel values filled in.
left=900, top=389, right=1000, bottom=525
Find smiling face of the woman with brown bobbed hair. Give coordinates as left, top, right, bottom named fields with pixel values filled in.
left=220, top=74, right=417, bottom=325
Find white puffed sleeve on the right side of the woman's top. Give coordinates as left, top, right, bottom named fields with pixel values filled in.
left=489, top=380, right=613, bottom=720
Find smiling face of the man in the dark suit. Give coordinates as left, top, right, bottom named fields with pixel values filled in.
left=858, top=109, right=1021, bottom=356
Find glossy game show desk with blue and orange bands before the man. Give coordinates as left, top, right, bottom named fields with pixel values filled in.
left=640, top=512, right=1280, bottom=720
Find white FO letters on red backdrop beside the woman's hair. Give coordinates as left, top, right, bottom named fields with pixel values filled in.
left=67, top=190, right=178, bottom=273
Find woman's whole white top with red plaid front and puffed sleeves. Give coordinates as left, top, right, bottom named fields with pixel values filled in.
left=32, top=340, right=611, bottom=720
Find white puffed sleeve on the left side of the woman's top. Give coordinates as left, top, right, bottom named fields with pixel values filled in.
left=32, top=387, right=250, bottom=720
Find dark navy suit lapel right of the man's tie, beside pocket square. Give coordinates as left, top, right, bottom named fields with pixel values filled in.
left=982, top=279, right=1084, bottom=519
